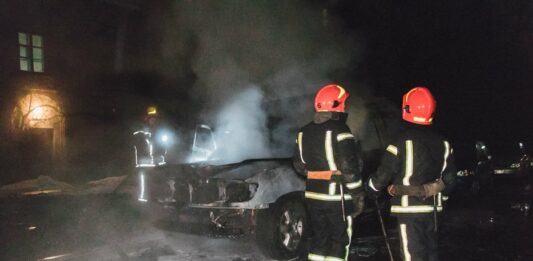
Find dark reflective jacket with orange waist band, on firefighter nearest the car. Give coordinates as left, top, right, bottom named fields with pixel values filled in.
left=293, top=112, right=362, bottom=204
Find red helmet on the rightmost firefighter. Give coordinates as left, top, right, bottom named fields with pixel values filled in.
left=402, top=87, right=437, bottom=125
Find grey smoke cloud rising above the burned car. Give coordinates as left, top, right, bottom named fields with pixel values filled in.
left=147, top=0, right=366, bottom=158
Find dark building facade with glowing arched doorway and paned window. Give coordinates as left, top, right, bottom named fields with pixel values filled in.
left=0, top=0, right=142, bottom=183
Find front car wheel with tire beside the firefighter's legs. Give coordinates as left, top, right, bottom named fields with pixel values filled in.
left=256, top=196, right=309, bottom=260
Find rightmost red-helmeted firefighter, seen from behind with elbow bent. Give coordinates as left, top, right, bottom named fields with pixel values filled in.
left=366, top=87, right=456, bottom=261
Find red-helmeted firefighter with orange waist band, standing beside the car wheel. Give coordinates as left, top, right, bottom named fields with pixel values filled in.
left=293, top=84, right=364, bottom=260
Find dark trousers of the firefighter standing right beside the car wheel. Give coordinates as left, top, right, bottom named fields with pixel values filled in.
left=307, top=202, right=352, bottom=261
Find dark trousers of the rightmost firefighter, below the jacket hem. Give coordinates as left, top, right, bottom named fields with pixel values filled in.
left=398, top=215, right=439, bottom=261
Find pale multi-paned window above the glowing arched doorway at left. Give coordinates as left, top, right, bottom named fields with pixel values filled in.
left=19, top=33, right=44, bottom=72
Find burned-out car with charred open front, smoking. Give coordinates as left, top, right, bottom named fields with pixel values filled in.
left=133, top=126, right=307, bottom=259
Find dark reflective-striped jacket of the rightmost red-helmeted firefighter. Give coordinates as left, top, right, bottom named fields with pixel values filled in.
left=368, top=125, right=456, bottom=217
